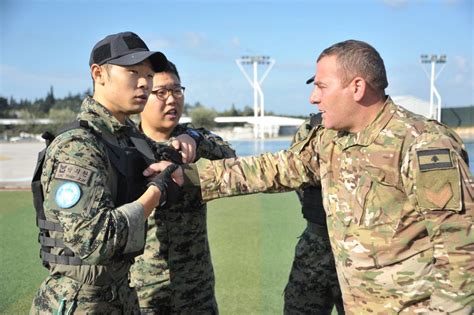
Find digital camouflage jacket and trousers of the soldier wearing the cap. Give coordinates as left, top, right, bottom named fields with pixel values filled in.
left=31, top=97, right=150, bottom=314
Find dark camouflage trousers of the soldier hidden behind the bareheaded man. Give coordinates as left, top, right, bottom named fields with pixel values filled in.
left=284, top=222, right=344, bottom=315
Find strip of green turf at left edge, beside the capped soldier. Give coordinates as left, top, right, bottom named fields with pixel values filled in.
left=0, top=191, right=47, bottom=314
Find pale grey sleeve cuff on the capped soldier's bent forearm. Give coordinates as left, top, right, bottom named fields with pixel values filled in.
left=116, top=201, right=145, bottom=254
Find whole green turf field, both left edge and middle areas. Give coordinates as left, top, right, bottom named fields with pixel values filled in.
left=0, top=191, right=305, bottom=315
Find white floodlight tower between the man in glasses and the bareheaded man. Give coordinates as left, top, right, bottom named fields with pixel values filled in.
left=235, top=56, right=275, bottom=138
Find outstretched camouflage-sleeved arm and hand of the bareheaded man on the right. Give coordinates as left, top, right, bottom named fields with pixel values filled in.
left=144, top=137, right=319, bottom=201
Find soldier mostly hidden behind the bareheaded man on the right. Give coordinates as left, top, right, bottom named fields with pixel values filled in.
left=284, top=113, right=344, bottom=315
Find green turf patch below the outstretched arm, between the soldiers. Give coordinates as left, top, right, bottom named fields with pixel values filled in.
left=208, top=193, right=305, bottom=314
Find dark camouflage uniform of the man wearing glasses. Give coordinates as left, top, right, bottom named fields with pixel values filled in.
left=131, top=125, right=235, bottom=314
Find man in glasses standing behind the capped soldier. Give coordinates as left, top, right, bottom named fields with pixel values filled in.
left=131, top=62, right=235, bottom=315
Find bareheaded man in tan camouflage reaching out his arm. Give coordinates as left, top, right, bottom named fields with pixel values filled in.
left=151, top=40, right=474, bottom=315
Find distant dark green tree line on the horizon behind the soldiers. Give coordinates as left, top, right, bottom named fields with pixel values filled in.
left=0, top=86, right=303, bottom=135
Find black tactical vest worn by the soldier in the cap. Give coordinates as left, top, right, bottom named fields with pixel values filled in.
left=31, top=120, right=155, bottom=268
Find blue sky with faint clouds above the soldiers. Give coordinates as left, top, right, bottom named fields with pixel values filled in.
left=0, top=0, right=474, bottom=115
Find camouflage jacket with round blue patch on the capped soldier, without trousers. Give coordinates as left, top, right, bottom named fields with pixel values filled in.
left=41, top=97, right=145, bottom=285
